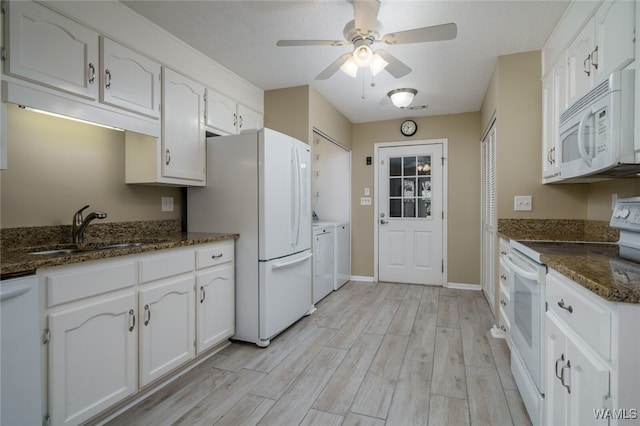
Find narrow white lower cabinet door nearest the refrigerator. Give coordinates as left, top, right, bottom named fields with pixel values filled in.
left=196, top=263, right=235, bottom=353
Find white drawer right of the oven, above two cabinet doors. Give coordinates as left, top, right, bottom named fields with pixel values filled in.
left=546, top=271, right=611, bottom=359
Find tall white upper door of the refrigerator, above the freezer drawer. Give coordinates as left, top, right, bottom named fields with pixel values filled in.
left=259, top=129, right=311, bottom=260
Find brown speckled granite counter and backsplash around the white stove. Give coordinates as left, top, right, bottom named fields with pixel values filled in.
left=498, top=219, right=640, bottom=303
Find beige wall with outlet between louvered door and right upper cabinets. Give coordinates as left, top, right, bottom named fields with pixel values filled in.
left=481, top=51, right=588, bottom=219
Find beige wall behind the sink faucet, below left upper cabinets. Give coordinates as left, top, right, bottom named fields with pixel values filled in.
left=0, top=104, right=183, bottom=228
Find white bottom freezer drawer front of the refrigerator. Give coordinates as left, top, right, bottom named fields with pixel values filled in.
left=260, top=250, right=312, bottom=345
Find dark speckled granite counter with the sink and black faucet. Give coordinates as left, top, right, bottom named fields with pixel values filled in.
left=0, top=221, right=239, bottom=278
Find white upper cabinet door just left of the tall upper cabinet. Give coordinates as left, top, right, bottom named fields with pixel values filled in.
left=100, top=37, right=160, bottom=118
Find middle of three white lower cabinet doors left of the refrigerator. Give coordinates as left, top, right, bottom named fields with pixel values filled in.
left=138, top=276, right=195, bottom=386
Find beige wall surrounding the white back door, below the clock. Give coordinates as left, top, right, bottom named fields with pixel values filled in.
left=351, top=112, right=480, bottom=284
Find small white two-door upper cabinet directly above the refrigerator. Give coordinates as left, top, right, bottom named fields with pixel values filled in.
left=205, top=88, right=262, bottom=135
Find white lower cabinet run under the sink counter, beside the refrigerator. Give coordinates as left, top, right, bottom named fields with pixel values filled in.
left=38, top=241, right=235, bottom=426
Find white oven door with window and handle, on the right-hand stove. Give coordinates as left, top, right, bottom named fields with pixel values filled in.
left=505, top=250, right=546, bottom=393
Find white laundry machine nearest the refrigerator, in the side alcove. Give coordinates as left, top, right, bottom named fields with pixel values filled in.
left=313, top=224, right=334, bottom=303
